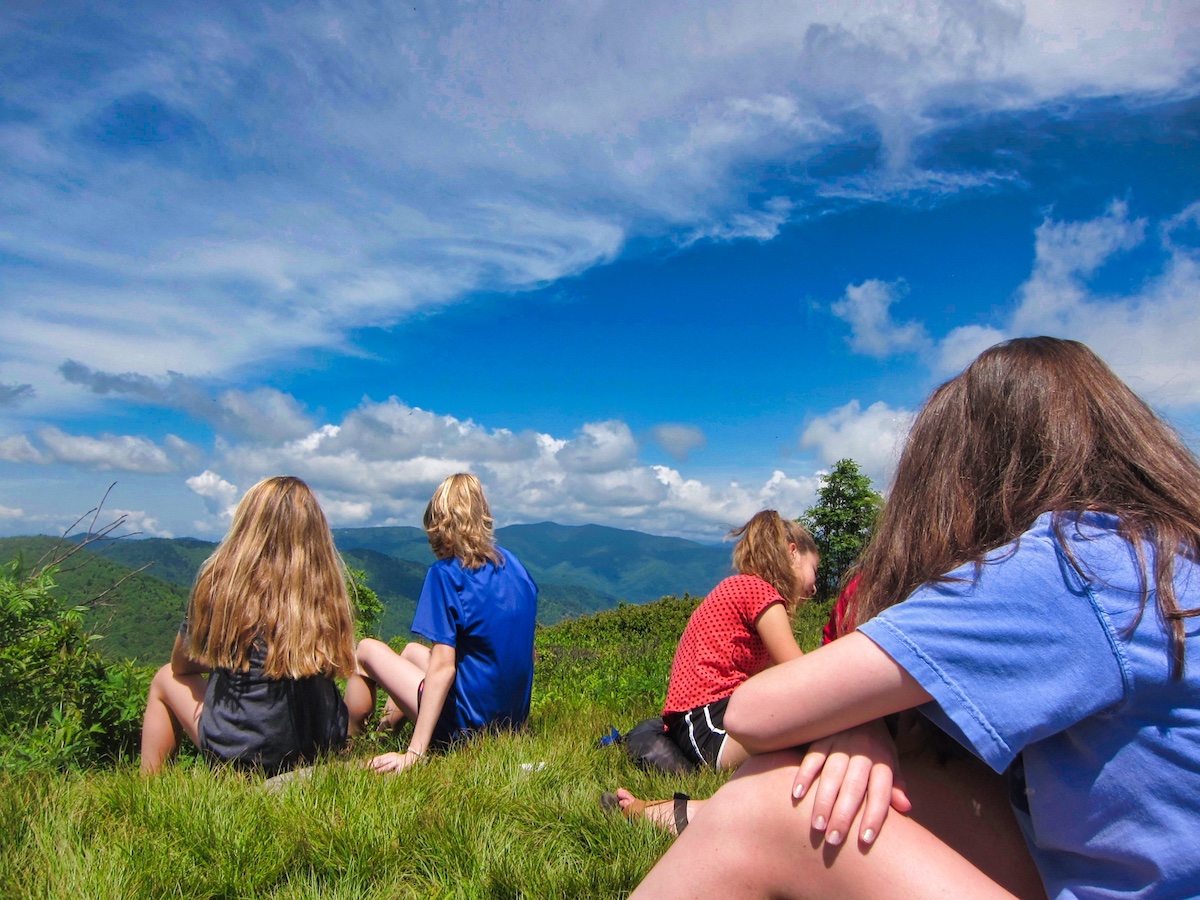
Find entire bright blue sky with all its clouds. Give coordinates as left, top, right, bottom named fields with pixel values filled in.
left=0, top=0, right=1200, bottom=540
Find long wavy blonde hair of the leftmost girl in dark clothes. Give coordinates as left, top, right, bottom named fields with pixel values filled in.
left=187, top=475, right=354, bottom=678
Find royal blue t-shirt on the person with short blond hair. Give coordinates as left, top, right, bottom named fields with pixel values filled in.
left=413, top=547, right=538, bottom=746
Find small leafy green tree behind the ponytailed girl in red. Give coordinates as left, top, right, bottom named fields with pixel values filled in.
left=800, top=458, right=883, bottom=599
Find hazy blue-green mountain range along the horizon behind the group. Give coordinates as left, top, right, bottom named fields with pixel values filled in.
left=0, top=522, right=731, bottom=664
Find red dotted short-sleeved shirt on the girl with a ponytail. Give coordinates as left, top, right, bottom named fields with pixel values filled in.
left=662, top=575, right=784, bottom=715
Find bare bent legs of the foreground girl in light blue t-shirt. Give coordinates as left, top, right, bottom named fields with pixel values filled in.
left=634, top=751, right=1044, bottom=898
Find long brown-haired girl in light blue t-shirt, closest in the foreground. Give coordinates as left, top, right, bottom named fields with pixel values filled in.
left=638, top=337, right=1200, bottom=898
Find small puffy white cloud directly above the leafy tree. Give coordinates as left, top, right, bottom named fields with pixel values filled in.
left=800, top=400, right=913, bottom=485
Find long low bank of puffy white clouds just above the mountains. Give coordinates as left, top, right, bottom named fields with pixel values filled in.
left=166, top=397, right=818, bottom=539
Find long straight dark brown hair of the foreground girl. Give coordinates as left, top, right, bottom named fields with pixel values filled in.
left=852, top=337, right=1200, bottom=677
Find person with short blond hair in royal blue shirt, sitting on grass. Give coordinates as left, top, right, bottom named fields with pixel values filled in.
left=347, top=473, right=538, bottom=772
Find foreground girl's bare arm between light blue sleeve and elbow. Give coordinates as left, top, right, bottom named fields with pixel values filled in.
left=725, top=634, right=930, bottom=754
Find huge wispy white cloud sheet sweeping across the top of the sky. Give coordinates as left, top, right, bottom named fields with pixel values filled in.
left=0, top=0, right=1200, bottom=412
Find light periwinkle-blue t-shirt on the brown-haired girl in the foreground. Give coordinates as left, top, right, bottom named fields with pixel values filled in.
left=859, top=514, right=1200, bottom=898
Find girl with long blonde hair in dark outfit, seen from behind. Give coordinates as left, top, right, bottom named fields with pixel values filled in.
left=142, top=475, right=354, bottom=774
